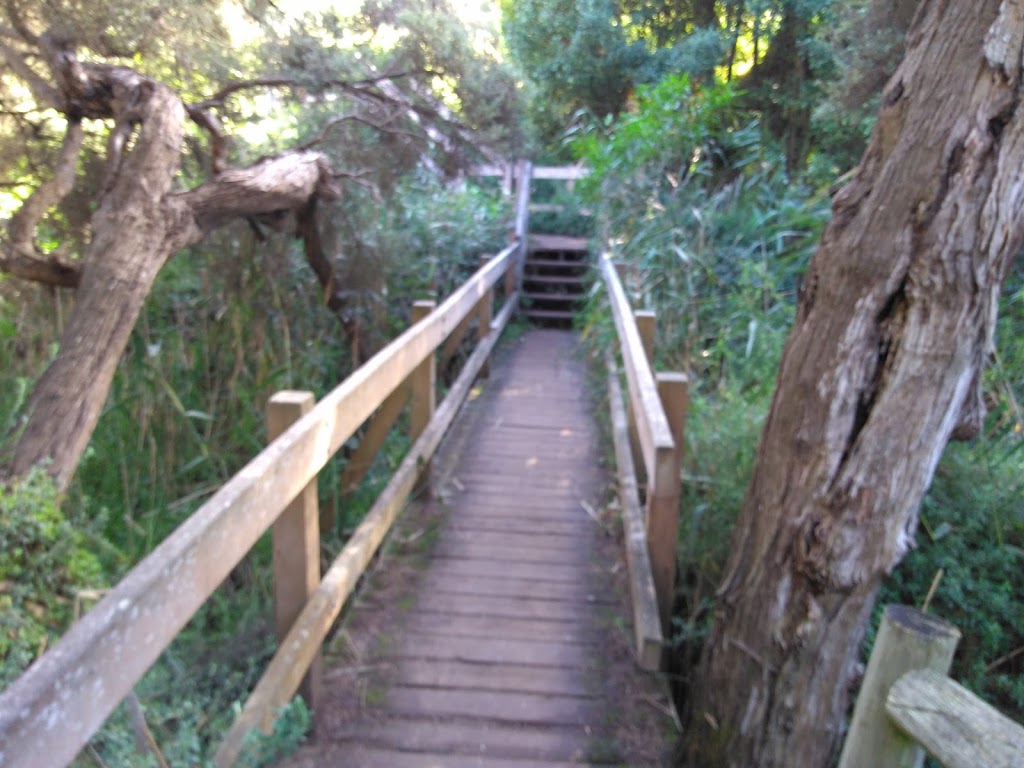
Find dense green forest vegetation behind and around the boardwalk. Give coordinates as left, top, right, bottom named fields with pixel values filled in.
left=0, top=0, right=1024, bottom=766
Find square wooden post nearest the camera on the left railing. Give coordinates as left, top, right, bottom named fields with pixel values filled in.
left=266, top=391, right=323, bottom=710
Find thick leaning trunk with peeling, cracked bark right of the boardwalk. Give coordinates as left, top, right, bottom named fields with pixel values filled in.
left=690, top=0, right=1024, bottom=768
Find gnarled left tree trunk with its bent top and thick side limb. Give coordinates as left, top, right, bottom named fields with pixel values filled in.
left=5, top=60, right=338, bottom=488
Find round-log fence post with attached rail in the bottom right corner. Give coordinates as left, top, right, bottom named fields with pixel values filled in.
left=839, top=605, right=1024, bottom=768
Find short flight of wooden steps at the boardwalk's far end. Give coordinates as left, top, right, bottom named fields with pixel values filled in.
left=522, top=234, right=590, bottom=328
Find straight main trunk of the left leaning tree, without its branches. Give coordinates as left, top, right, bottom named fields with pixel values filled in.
left=11, top=81, right=184, bottom=487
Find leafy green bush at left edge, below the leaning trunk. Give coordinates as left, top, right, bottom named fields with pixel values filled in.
left=0, top=470, right=105, bottom=688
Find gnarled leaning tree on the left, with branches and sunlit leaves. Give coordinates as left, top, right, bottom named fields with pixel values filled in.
left=0, top=0, right=511, bottom=487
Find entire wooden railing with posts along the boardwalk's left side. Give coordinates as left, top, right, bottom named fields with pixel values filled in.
left=0, top=166, right=528, bottom=768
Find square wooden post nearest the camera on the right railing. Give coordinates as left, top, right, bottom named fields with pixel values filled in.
left=647, top=373, right=689, bottom=638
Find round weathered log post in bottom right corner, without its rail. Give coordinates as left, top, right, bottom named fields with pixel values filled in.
left=839, top=605, right=961, bottom=768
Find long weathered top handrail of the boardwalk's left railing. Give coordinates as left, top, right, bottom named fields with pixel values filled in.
left=0, top=242, right=521, bottom=768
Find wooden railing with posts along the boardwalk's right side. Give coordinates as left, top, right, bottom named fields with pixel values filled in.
left=600, top=254, right=688, bottom=669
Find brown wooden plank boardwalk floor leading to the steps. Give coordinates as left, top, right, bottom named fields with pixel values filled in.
left=280, top=330, right=655, bottom=768
